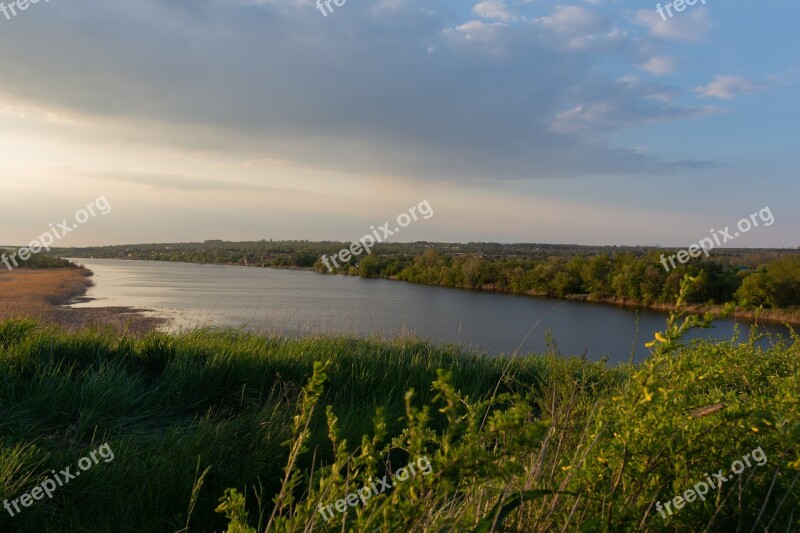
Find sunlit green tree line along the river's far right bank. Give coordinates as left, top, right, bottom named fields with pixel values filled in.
left=324, top=249, right=800, bottom=308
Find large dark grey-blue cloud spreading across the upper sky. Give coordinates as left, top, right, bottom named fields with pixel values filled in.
left=0, top=0, right=724, bottom=182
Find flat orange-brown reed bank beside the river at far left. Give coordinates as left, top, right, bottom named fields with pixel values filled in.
left=0, top=268, right=165, bottom=335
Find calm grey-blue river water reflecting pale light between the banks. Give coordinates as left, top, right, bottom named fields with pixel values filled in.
left=67, top=259, right=785, bottom=362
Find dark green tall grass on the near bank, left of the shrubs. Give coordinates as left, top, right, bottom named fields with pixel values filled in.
left=0, top=320, right=613, bottom=531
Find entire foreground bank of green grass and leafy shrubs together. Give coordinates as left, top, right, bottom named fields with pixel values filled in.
left=0, top=310, right=800, bottom=532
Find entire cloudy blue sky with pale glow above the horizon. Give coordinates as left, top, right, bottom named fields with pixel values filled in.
left=0, top=0, right=800, bottom=248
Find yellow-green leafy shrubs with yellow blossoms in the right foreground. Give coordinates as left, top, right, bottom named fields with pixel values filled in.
left=212, top=277, right=800, bottom=532
